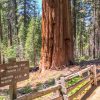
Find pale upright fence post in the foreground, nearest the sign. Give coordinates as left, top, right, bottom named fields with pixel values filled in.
left=60, top=77, right=68, bottom=100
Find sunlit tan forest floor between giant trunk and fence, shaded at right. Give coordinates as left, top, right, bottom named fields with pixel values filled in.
left=18, top=59, right=100, bottom=88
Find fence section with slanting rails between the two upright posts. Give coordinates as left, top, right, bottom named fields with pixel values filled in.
left=60, top=66, right=96, bottom=100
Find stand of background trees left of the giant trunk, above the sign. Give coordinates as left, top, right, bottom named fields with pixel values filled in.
left=0, top=0, right=41, bottom=65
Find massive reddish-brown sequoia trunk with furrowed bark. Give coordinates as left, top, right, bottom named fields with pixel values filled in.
left=40, top=0, right=73, bottom=70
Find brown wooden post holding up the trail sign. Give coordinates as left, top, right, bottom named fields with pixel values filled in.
left=8, top=58, right=17, bottom=100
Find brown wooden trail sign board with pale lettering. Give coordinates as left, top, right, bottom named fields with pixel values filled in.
left=0, top=61, right=29, bottom=87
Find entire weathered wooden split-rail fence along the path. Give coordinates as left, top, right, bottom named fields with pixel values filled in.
left=16, top=65, right=100, bottom=100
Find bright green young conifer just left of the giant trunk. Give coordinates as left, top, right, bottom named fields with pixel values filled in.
left=25, top=18, right=41, bottom=65
